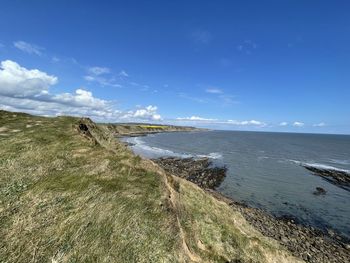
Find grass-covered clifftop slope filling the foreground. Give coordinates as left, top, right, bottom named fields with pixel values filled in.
left=0, top=111, right=297, bottom=262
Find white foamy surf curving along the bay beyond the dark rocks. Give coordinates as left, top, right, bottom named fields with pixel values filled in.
left=125, top=137, right=222, bottom=159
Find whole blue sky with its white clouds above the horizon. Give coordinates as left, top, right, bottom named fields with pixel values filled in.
left=0, top=0, right=350, bottom=134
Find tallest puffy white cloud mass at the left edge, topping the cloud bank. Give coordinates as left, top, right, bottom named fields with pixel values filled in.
left=0, top=60, right=57, bottom=97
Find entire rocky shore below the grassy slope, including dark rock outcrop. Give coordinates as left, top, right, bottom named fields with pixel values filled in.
left=153, top=157, right=350, bottom=263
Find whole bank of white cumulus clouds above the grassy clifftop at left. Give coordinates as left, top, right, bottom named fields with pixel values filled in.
left=0, top=60, right=161, bottom=122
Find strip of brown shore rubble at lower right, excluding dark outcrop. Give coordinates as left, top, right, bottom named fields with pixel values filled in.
left=210, top=191, right=350, bottom=263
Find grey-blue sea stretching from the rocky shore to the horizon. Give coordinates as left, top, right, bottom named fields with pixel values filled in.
left=123, top=131, right=350, bottom=238
